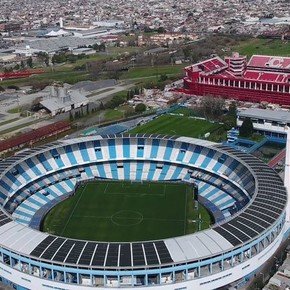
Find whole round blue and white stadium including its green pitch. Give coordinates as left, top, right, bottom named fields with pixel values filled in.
left=0, top=134, right=290, bottom=290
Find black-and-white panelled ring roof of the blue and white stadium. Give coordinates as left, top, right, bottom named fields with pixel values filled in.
left=0, top=134, right=287, bottom=268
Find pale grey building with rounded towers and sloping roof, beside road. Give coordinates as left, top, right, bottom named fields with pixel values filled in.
left=40, top=86, right=89, bottom=116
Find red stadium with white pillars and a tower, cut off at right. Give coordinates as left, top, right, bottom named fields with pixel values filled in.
left=184, top=53, right=290, bottom=106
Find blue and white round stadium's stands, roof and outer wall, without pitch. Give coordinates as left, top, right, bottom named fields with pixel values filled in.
left=0, top=134, right=290, bottom=290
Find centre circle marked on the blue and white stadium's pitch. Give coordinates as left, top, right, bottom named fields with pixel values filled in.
left=111, top=210, right=143, bottom=227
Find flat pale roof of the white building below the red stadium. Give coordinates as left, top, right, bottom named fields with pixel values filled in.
left=238, top=108, right=290, bottom=124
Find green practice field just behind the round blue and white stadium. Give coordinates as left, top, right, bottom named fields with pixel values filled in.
left=130, top=115, right=221, bottom=138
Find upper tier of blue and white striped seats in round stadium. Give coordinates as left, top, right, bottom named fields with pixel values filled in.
left=0, top=138, right=254, bottom=204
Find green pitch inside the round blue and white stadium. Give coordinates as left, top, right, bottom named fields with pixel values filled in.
left=43, top=181, right=211, bottom=242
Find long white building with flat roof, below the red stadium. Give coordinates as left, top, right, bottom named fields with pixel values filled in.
left=237, top=108, right=290, bottom=138
